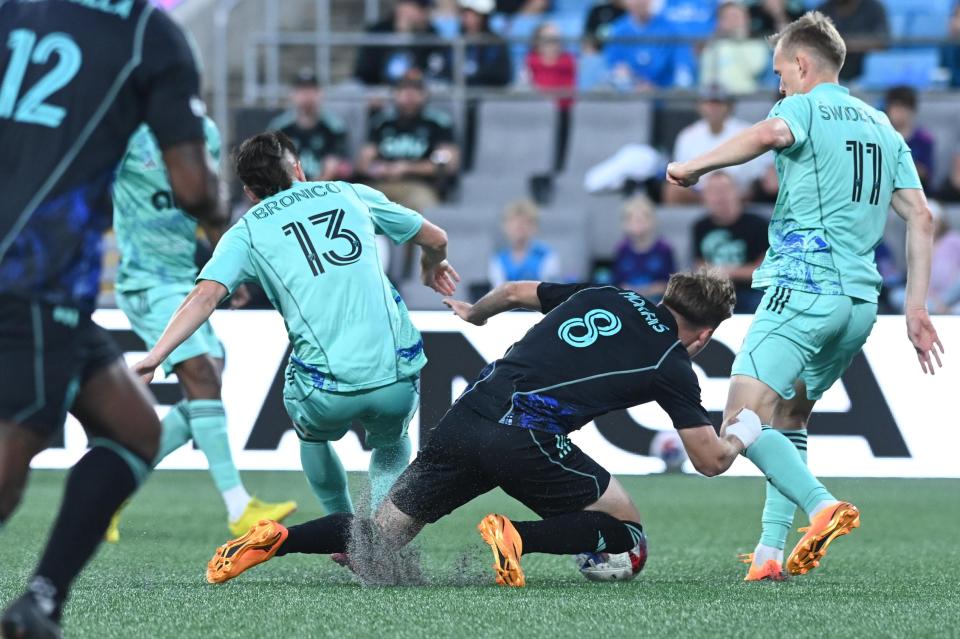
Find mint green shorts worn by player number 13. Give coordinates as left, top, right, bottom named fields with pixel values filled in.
left=283, top=366, right=420, bottom=448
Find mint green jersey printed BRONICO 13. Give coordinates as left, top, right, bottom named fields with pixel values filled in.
left=197, top=182, right=427, bottom=392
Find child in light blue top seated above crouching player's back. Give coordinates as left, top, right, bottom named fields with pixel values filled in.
left=489, top=199, right=562, bottom=287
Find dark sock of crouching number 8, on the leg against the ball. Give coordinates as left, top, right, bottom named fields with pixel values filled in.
left=513, top=510, right=643, bottom=555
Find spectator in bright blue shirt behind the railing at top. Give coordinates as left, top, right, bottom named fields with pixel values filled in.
left=603, top=0, right=696, bottom=90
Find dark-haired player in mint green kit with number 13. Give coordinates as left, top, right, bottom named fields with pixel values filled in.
left=135, top=132, right=459, bottom=524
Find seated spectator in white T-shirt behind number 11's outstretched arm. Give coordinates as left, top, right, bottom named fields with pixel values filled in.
left=662, top=85, right=772, bottom=204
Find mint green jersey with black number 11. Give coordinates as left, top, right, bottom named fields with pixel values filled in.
left=753, top=83, right=921, bottom=303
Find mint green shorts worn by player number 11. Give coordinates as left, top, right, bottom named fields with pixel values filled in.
left=731, top=286, right=877, bottom=400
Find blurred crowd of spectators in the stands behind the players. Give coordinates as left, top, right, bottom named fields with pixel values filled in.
left=95, top=0, right=960, bottom=313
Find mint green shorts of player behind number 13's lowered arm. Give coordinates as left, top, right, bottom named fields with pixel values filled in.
left=117, top=284, right=223, bottom=375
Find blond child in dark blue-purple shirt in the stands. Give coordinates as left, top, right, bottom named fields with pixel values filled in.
left=613, top=196, right=676, bottom=301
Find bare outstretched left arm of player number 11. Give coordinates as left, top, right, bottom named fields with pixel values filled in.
left=667, top=118, right=795, bottom=186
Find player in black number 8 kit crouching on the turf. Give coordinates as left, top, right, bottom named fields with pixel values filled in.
left=197, top=271, right=796, bottom=586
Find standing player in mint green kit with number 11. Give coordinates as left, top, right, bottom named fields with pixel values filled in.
left=667, top=12, right=943, bottom=581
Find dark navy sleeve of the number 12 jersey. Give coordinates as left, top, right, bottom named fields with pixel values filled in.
left=134, top=10, right=204, bottom=149
